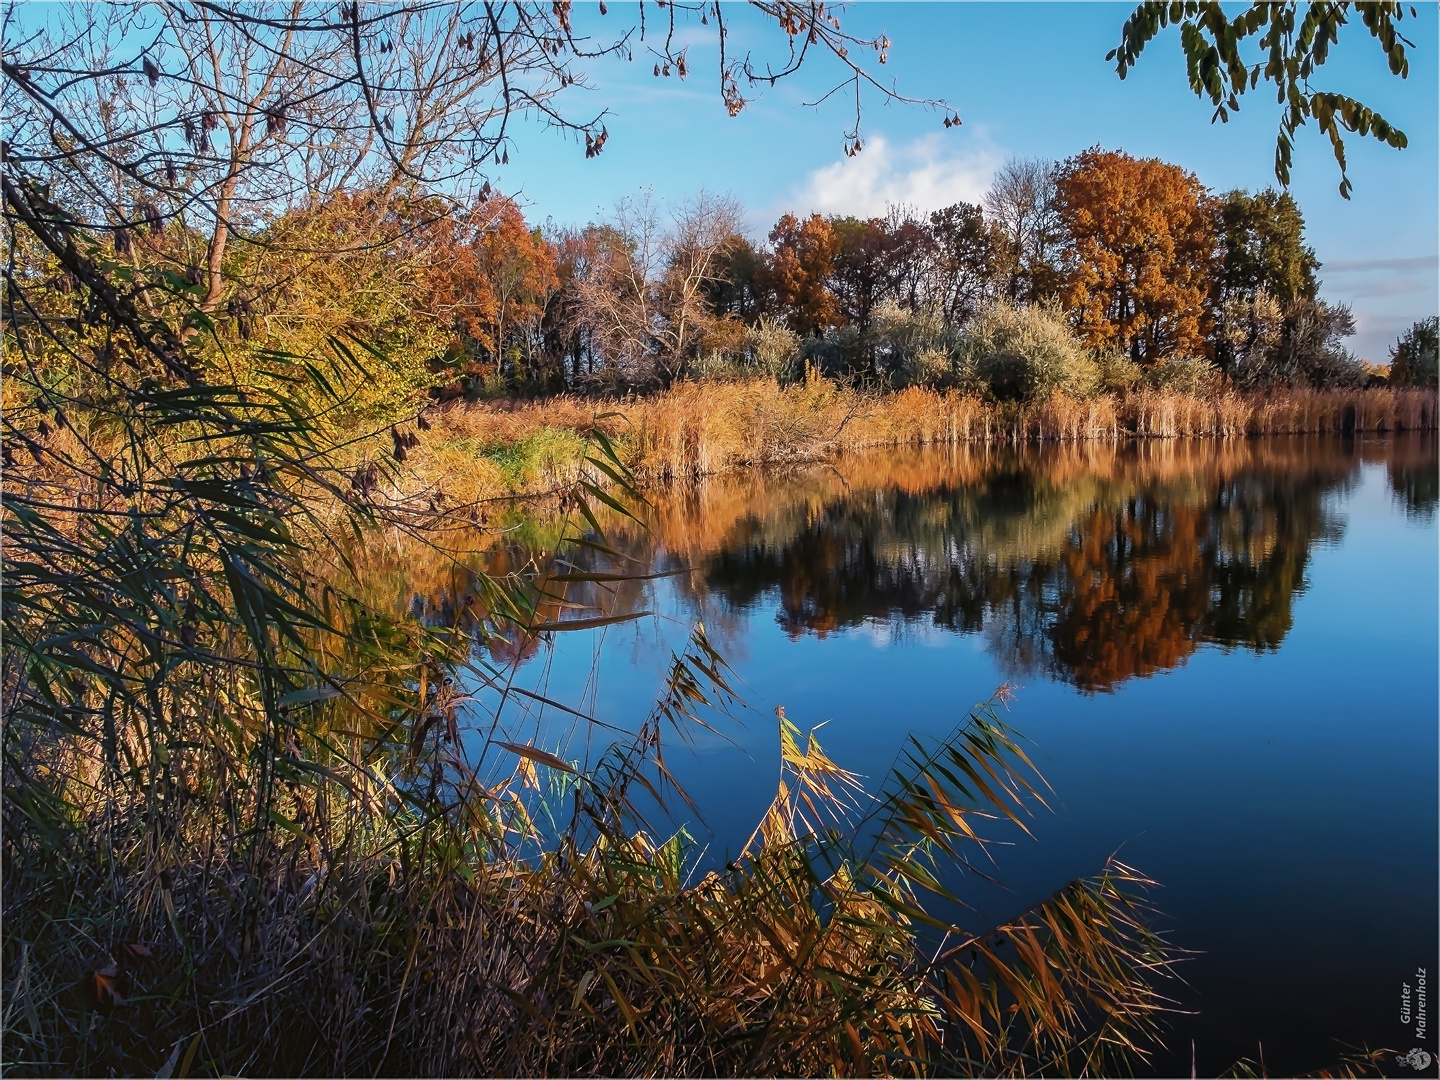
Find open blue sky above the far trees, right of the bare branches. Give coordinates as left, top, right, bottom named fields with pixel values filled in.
left=495, top=0, right=1440, bottom=361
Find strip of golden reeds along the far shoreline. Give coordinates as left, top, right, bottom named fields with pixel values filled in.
left=388, top=379, right=1440, bottom=503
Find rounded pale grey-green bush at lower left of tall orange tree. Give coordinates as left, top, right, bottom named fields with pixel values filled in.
left=956, top=302, right=1100, bottom=402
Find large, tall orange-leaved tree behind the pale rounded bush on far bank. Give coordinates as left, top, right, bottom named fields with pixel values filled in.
left=1056, top=148, right=1215, bottom=363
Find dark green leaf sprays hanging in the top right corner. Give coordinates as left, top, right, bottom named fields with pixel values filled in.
left=1106, top=0, right=1414, bottom=199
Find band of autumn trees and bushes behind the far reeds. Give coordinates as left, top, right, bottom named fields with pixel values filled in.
left=137, top=148, right=1436, bottom=399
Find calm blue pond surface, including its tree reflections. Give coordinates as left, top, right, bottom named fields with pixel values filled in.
left=415, top=436, right=1440, bottom=1076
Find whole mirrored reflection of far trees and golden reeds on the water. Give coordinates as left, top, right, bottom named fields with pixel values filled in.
left=377, top=436, right=1440, bottom=691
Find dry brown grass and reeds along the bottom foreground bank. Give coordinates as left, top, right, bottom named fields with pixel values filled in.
left=4, top=639, right=1171, bottom=1076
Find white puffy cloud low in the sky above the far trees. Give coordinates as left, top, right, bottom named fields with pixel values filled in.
left=782, top=132, right=1005, bottom=217
